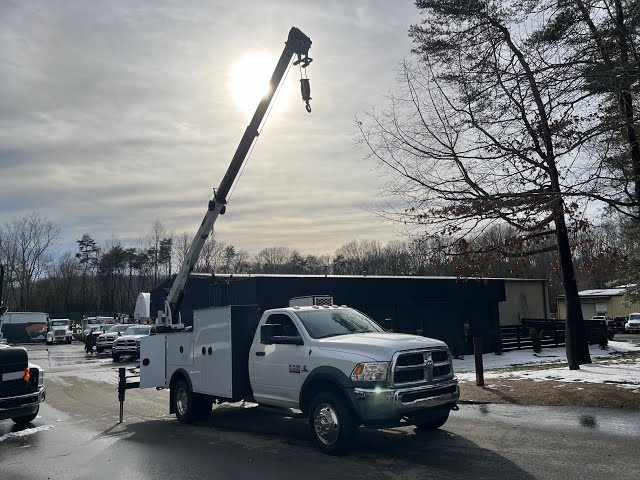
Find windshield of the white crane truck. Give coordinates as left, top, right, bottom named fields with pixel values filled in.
left=296, top=308, right=384, bottom=338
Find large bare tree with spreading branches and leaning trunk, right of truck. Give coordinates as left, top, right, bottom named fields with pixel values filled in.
left=358, top=0, right=604, bottom=369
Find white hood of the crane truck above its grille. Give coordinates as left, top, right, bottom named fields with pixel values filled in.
left=318, top=332, right=447, bottom=362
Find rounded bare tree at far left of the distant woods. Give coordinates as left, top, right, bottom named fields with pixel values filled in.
left=0, top=213, right=60, bottom=311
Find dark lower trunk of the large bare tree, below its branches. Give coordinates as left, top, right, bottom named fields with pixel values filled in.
left=554, top=204, right=591, bottom=370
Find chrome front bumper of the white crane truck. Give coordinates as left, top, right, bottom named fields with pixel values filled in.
left=354, top=377, right=460, bottom=425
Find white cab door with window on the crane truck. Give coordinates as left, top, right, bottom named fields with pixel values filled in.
left=249, top=313, right=311, bottom=407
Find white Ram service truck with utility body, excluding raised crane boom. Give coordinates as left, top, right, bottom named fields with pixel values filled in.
left=140, top=305, right=459, bottom=454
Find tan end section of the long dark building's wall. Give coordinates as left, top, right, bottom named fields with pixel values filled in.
left=498, top=280, right=549, bottom=325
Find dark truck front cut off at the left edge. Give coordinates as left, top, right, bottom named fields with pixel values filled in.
left=0, top=345, right=46, bottom=426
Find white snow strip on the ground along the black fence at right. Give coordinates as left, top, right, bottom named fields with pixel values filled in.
left=453, top=342, right=640, bottom=393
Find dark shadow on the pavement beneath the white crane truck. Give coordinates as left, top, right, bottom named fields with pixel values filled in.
left=109, top=407, right=535, bottom=479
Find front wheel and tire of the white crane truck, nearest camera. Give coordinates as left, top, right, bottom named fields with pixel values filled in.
left=309, top=392, right=357, bottom=455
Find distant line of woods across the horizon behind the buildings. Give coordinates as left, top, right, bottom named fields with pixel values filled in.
left=0, top=213, right=630, bottom=316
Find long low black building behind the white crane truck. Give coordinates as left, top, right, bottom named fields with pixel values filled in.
left=151, top=274, right=505, bottom=354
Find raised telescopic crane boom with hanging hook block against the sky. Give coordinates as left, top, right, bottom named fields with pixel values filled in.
left=156, top=27, right=312, bottom=329
